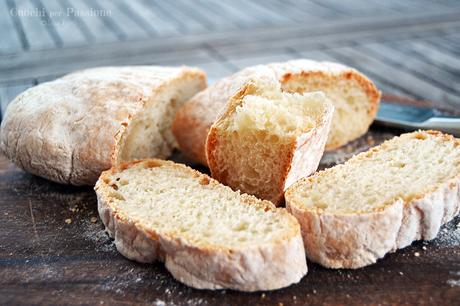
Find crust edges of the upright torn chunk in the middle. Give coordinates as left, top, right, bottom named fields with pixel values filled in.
left=206, top=78, right=334, bottom=205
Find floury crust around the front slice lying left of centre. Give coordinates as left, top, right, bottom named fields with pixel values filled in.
left=95, top=159, right=307, bottom=291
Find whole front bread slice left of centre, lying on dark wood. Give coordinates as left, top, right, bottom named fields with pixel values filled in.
left=95, top=159, right=307, bottom=291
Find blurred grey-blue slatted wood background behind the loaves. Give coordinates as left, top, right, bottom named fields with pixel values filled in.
left=0, top=0, right=460, bottom=119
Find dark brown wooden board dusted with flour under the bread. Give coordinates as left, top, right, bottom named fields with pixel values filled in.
left=0, top=97, right=460, bottom=306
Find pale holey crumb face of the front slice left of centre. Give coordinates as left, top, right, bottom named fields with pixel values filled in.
left=99, top=159, right=295, bottom=248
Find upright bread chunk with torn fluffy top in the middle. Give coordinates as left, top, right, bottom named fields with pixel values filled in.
left=206, top=80, right=333, bottom=204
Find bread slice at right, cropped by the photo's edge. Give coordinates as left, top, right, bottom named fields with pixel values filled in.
left=285, top=131, right=460, bottom=268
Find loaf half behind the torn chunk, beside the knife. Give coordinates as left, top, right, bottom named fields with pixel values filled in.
left=173, top=59, right=380, bottom=165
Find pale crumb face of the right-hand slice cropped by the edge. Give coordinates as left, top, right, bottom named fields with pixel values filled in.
left=287, top=131, right=460, bottom=214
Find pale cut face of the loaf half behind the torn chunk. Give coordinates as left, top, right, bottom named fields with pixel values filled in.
left=282, top=67, right=380, bottom=150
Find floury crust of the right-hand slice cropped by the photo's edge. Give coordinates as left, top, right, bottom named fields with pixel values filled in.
left=285, top=131, right=460, bottom=269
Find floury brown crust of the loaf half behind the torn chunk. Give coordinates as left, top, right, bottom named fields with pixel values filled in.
left=173, top=60, right=380, bottom=165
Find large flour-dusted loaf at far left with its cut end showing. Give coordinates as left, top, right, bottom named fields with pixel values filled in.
left=0, top=66, right=206, bottom=185
